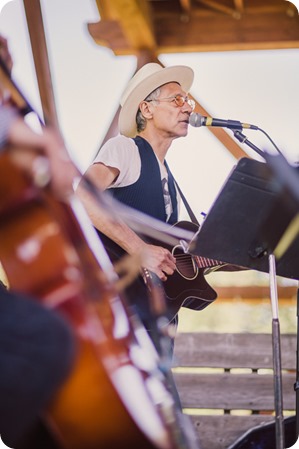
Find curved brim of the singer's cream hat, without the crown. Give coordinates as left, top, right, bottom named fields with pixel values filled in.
left=118, top=66, right=194, bottom=137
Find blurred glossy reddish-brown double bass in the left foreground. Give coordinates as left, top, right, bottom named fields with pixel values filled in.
left=0, top=60, right=199, bottom=449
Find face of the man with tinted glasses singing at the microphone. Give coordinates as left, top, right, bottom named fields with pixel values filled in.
left=152, top=83, right=192, bottom=138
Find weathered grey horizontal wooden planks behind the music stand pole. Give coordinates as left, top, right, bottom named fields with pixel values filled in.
left=173, top=332, right=297, bottom=449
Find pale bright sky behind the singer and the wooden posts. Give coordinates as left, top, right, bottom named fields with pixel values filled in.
left=0, top=0, right=299, bottom=216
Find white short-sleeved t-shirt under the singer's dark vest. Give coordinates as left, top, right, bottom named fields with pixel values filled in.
left=94, top=135, right=178, bottom=220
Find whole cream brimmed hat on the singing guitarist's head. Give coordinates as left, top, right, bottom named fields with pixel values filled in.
left=118, top=62, right=194, bottom=137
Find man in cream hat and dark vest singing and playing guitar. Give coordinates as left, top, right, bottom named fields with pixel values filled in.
left=77, top=63, right=216, bottom=346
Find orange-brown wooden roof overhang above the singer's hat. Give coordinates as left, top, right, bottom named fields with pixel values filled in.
left=89, top=0, right=299, bottom=55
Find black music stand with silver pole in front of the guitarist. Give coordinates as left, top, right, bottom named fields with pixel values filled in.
left=193, top=158, right=299, bottom=449
